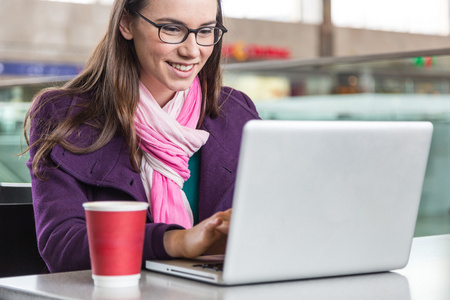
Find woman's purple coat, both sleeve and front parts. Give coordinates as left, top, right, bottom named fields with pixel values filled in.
left=27, top=88, right=259, bottom=272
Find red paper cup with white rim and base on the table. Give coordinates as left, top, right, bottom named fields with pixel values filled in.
left=83, top=201, right=148, bottom=287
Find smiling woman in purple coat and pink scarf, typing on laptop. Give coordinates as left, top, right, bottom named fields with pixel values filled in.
left=25, top=0, right=258, bottom=272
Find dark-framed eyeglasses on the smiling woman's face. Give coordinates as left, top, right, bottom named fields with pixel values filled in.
left=135, top=11, right=228, bottom=46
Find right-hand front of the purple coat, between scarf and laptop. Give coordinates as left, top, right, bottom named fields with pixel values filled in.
left=199, top=92, right=259, bottom=221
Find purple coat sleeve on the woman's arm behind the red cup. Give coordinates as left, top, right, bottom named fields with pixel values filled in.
left=27, top=92, right=180, bottom=272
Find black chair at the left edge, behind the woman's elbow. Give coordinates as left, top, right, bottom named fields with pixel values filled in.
left=0, top=183, right=46, bottom=277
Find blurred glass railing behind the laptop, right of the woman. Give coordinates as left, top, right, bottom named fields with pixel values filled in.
left=224, top=49, right=450, bottom=236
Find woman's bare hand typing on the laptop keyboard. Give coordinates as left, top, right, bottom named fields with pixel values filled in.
left=164, top=209, right=231, bottom=258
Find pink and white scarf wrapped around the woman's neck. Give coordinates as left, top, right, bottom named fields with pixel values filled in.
left=134, top=77, right=209, bottom=228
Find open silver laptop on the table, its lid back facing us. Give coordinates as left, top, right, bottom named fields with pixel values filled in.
left=146, top=120, right=433, bottom=285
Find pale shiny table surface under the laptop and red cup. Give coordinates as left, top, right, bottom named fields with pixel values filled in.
left=0, top=235, right=450, bottom=300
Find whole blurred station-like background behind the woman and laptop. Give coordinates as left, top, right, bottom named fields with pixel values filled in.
left=0, top=0, right=450, bottom=236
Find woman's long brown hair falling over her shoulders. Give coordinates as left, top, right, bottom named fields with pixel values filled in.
left=24, top=0, right=223, bottom=179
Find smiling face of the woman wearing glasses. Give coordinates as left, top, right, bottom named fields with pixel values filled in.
left=120, top=0, right=218, bottom=106
